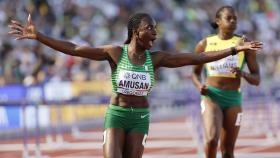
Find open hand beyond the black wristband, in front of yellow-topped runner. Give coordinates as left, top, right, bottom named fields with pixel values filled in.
left=236, top=35, right=263, bottom=51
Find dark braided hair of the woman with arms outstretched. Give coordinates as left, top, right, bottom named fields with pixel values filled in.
left=125, top=13, right=151, bottom=44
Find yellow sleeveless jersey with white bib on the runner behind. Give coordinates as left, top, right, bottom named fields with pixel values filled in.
left=205, top=35, right=245, bottom=78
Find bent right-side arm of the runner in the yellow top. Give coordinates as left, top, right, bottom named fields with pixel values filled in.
left=241, top=51, right=261, bottom=86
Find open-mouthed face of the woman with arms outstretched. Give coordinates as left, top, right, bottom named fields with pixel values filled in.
left=136, top=18, right=157, bottom=49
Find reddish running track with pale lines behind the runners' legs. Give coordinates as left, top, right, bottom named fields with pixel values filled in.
left=0, top=115, right=280, bottom=158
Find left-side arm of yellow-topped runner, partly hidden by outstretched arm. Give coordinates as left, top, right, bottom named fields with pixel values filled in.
left=192, top=39, right=207, bottom=94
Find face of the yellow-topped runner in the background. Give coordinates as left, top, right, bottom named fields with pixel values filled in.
left=216, top=9, right=237, bottom=32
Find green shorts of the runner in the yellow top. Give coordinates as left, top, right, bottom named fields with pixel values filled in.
left=202, top=86, right=242, bottom=109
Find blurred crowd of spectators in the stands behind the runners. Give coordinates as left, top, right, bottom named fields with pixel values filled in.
left=0, top=0, right=280, bottom=85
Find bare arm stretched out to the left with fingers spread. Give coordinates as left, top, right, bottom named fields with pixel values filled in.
left=9, top=15, right=112, bottom=60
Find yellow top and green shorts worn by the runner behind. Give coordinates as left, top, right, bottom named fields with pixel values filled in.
left=201, top=35, right=245, bottom=109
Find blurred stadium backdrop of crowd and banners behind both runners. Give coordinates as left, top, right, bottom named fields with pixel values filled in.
left=0, top=0, right=280, bottom=157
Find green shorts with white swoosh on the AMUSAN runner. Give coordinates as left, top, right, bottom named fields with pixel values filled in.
left=104, top=105, right=150, bottom=134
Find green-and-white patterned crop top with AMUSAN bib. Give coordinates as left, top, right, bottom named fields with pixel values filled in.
left=111, top=45, right=155, bottom=96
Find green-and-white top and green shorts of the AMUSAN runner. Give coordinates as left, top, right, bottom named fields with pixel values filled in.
left=104, top=45, right=155, bottom=134
